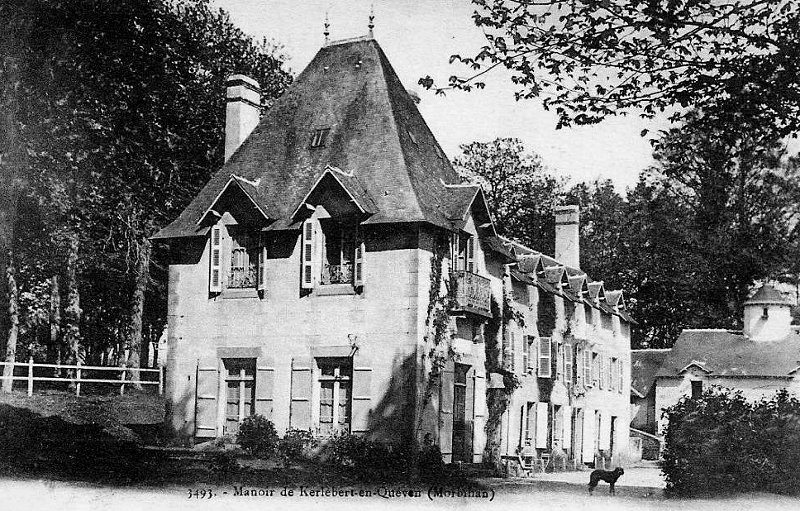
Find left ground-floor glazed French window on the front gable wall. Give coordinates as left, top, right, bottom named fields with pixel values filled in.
left=222, top=358, right=256, bottom=435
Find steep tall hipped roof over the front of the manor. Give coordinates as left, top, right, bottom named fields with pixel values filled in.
left=155, top=38, right=477, bottom=238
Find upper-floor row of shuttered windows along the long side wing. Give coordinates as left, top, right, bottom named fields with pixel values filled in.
left=508, top=332, right=624, bottom=393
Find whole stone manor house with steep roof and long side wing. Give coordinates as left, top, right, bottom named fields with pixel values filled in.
left=155, top=36, right=632, bottom=463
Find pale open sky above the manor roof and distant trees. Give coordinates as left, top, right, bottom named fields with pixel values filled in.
left=213, top=0, right=667, bottom=192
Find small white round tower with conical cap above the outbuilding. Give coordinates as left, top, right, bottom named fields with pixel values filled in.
left=744, top=284, right=792, bottom=342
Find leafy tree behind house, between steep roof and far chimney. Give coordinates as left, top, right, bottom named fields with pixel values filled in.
left=454, top=138, right=565, bottom=253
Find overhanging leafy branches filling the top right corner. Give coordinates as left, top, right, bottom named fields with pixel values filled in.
left=420, top=0, right=800, bottom=136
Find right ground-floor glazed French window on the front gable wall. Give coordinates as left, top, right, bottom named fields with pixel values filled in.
left=317, top=358, right=353, bottom=435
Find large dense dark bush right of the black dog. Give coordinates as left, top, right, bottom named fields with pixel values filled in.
left=661, top=388, right=800, bottom=495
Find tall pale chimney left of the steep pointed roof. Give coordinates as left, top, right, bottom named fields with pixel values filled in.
left=225, top=75, right=261, bottom=161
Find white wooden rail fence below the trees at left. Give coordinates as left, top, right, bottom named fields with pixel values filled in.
left=0, top=358, right=164, bottom=396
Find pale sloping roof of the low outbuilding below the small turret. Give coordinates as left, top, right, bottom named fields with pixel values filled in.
left=656, top=329, right=800, bottom=377
